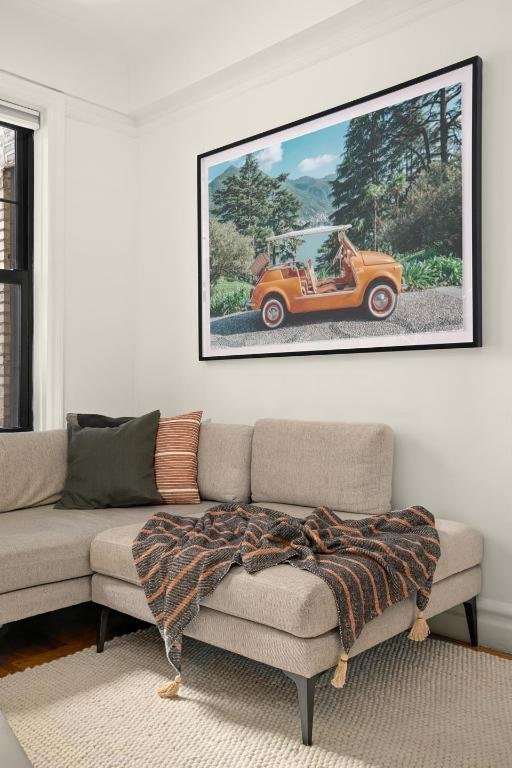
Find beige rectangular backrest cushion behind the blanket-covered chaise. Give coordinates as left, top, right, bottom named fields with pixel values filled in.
left=251, top=419, right=393, bottom=515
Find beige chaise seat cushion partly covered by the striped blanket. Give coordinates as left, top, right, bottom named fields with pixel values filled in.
left=91, top=504, right=482, bottom=637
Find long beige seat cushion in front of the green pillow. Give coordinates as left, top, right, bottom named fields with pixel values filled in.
left=0, top=500, right=214, bottom=593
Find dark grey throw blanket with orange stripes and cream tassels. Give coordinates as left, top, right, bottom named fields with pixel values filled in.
left=132, top=504, right=440, bottom=697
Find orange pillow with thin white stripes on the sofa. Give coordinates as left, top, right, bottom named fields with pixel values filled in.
left=155, top=411, right=203, bottom=504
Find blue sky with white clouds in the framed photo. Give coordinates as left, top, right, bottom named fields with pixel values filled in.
left=208, top=120, right=350, bottom=182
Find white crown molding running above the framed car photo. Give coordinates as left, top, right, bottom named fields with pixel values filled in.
left=130, top=0, right=463, bottom=133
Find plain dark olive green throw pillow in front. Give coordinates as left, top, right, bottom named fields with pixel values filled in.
left=55, top=411, right=162, bottom=509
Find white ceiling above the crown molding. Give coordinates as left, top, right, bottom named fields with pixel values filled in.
left=10, top=0, right=368, bottom=114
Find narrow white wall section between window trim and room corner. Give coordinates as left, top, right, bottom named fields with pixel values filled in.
left=62, top=117, right=137, bottom=415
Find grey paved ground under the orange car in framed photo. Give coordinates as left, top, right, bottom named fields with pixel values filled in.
left=210, top=288, right=462, bottom=347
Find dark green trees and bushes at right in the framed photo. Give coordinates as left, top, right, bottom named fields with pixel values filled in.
left=317, top=84, right=461, bottom=274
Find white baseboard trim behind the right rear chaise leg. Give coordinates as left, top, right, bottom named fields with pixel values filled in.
left=429, top=597, right=512, bottom=653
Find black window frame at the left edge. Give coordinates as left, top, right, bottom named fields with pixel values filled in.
left=0, top=122, right=34, bottom=433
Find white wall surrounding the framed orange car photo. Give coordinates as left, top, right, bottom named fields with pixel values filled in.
left=136, top=0, right=512, bottom=649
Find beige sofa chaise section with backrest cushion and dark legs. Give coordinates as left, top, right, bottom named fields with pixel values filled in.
left=91, top=419, right=482, bottom=744
